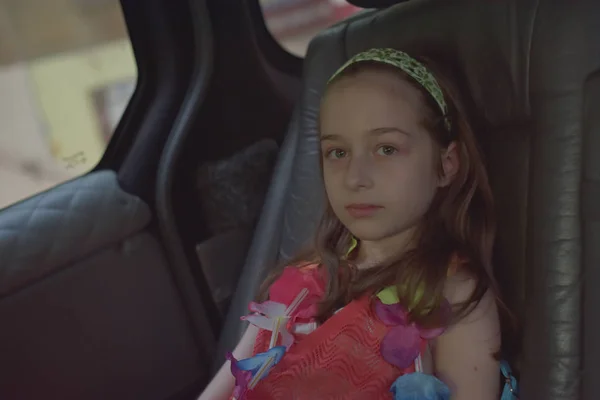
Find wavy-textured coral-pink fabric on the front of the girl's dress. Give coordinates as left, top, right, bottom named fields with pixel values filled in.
left=240, top=268, right=426, bottom=400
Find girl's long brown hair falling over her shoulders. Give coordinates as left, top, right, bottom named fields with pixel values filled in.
left=261, top=58, right=496, bottom=327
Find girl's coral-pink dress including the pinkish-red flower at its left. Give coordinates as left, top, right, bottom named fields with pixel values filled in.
left=227, top=265, right=441, bottom=400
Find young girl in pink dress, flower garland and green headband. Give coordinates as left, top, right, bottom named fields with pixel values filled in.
left=200, top=49, right=516, bottom=400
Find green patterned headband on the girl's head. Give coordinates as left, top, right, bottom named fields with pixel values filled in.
left=327, top=49, right=451, bottom=132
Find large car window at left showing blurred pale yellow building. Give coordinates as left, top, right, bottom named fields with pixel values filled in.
left=0, top=0, right=137, bottom=208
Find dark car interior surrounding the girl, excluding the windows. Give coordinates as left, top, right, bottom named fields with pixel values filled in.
left=0, top=0, right=600, bottom=400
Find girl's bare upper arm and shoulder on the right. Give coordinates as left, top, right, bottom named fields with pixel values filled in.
left=434, top=277, right=501, bottom=400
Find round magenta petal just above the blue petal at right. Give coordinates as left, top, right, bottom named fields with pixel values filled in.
left=380, top=325, right=421, bottom=368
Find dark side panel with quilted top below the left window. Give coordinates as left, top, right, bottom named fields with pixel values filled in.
left=0, top=171, right=201, bottom=399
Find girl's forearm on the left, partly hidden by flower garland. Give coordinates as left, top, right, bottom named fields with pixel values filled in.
left=198, top=325, right=258, bottom=400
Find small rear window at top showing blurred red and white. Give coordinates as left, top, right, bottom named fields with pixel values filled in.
left=260, top=0, right=361, bottom=57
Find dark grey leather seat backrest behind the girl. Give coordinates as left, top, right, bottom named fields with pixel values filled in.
left=217, top=0, right=600, bottom=400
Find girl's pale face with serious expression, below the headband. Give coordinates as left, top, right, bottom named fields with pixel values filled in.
left=320, top=71, right=447, bottom=245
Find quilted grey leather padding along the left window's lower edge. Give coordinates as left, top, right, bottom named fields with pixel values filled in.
left=0, top=171, right=151, bottom=298
